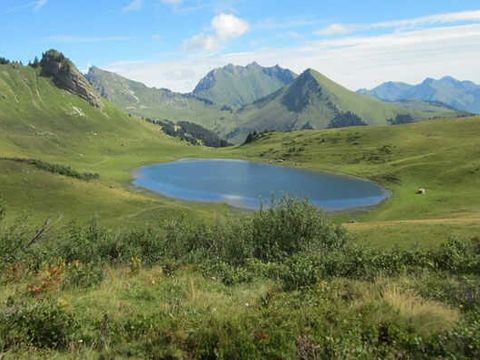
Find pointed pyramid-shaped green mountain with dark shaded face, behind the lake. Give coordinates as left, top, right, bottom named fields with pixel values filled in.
left=228, top=69, right=457, bottom=141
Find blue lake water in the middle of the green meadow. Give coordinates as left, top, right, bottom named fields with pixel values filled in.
left=133, top=159, right=388, bottom=211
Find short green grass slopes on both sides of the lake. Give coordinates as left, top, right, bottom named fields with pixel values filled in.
left=0, top=62, right=480, bottom=245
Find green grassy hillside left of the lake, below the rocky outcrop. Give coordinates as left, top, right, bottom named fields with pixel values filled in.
left=0, top=65, right=231, bottom=223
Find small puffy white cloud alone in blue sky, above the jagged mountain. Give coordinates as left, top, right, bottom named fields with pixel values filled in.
left=184, top=13, right=250, bottom=51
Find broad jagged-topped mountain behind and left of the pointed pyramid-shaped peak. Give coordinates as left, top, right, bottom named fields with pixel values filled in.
left=193, top=63, right=297, bottom=108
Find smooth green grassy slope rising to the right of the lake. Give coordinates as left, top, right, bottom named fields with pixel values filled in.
left=226, top=117, right=480, bottom=245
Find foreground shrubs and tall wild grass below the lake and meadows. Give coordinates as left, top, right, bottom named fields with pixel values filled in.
left=0, top=199, right=480, bottom=359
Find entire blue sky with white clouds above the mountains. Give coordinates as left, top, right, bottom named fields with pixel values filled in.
left=0, top=0, right=480, bottom=92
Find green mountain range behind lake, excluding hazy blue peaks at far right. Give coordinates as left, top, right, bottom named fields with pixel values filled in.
left=86, top=63, right=462, bottom=143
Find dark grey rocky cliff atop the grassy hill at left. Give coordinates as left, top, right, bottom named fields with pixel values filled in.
left=40, top=50, right=102, bottom=108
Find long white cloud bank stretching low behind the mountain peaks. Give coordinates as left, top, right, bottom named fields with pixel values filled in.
left=108, top=24, right=480, bottom=92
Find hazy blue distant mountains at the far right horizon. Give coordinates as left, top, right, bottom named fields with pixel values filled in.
left=359, top=76, right=480, bottom=114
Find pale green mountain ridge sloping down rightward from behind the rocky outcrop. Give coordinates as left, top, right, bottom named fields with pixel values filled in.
left=86, top=67, right=234, bottom=133
